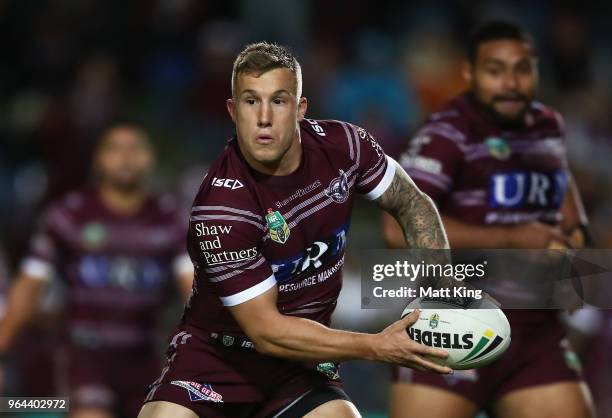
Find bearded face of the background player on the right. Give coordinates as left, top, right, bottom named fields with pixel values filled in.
left=465, top=40, right=538, bottom=124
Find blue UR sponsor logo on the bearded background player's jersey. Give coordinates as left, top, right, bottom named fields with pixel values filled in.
left=489, top=170, right=567, bottom=208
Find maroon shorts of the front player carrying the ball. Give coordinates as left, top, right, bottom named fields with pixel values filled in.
left=145, top=331, right=342, bottom=418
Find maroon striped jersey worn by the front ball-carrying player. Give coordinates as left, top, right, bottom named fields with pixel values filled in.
left=184, top=116, right=395, bottom=336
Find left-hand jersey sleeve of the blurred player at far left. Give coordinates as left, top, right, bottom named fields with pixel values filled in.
left=21, top=205, right=65, bottom=280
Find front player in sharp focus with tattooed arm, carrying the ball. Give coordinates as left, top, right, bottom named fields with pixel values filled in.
left=139, top=43, right=451, bottom=418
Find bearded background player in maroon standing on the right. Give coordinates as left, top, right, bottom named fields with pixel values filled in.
left=385, top=22, right=591, bottom=418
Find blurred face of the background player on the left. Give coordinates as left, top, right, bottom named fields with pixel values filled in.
left=96, top=126, right=153, bottom=190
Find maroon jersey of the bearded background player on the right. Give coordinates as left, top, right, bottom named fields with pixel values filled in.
left=399, top=93, right=568, bottom=322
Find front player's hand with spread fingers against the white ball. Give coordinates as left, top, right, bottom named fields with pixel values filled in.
left=376, top=309, right=453, bottom=374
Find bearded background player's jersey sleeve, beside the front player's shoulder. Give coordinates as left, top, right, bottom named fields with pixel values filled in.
left=399, top=125, right=463, bottom=203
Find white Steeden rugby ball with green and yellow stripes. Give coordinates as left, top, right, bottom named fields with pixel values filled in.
left=402, top=298, right=510, bottom=370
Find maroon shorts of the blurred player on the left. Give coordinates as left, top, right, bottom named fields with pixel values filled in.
left=62, top=347, right=162, bottom=417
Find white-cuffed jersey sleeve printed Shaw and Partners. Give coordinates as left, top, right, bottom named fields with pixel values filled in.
left=189, top=205, right=276, bottom=306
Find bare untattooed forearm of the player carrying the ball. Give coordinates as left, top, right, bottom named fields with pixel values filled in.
left=249, top=315, right=378, bottom=361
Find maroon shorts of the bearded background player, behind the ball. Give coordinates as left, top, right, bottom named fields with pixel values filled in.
left=392, top=319, right=581, bottom=407
